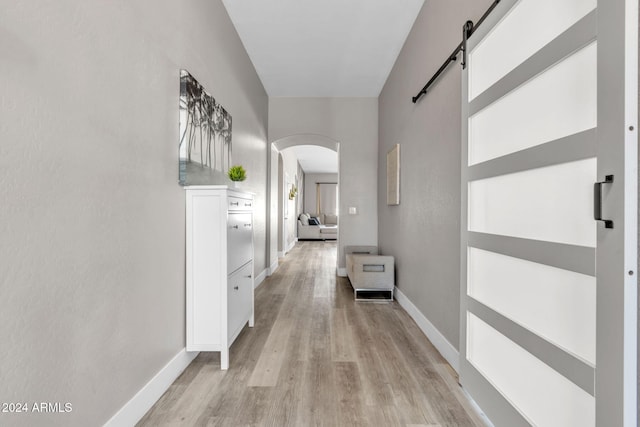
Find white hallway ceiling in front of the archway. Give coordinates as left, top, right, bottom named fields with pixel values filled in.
left=223, top=0, right=424, bottom=98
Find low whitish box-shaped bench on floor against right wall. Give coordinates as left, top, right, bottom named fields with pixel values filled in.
left=345, top=246, right=395, bottom=301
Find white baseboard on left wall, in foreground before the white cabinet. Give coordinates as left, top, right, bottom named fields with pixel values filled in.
left=105, top=349, right=198, bottom=427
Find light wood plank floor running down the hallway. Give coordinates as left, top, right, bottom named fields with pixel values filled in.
left=138, top=242, right=484, bottom=427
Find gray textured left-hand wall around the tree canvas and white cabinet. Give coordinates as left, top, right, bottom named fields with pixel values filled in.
left=0, top=0, right=268, bottom=426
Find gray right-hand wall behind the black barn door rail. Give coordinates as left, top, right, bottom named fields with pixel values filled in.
left=378, top=0, right=492, bottom=348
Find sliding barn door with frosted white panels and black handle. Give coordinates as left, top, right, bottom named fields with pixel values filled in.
left=460, top=0, right=638, bottom=427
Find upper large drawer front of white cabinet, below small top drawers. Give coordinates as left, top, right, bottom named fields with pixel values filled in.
left=227, top=212, right=253, bottom=274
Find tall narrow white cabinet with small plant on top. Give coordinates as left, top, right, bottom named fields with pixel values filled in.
left=185, top=186, right=253, bottom=369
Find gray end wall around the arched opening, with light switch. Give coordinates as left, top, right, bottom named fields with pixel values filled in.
left=269, top=98, right=378, bottom=268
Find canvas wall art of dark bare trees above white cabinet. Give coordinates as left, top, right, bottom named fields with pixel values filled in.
left=179, top=70, right=232, bottom=185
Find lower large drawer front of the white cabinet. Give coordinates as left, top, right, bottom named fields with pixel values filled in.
left=227, top=262, right=253, bottom=339
